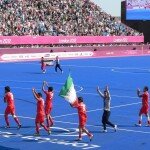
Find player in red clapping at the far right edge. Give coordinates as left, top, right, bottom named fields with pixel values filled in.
left=135, top=86, right=150, bottom=126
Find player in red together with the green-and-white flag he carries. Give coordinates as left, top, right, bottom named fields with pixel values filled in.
left=59, top=75, right=93, bottom=141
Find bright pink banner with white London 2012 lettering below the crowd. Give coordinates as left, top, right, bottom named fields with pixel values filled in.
left=0, top=36, right=144, bottom=45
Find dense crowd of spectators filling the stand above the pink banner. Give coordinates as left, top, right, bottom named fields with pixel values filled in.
left=0, top=0, right=139, bottom=36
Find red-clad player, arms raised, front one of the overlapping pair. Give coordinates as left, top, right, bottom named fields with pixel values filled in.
left=32, top=88, right=50, bottom=136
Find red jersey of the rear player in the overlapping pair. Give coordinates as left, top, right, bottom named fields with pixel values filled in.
left=44, top=91, right=54, bottom=108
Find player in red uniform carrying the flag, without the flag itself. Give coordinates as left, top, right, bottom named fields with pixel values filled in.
left=71, top=97, right=93, bottom=141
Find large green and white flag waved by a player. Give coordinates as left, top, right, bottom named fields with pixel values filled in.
left=59, top=75, right=77, bottom=105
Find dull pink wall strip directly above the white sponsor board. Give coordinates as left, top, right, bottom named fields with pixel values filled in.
left=0, top=45, right=150, bottom=54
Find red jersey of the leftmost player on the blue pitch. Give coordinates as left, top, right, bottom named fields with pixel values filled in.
left=4, top=92, right=15, bottom=107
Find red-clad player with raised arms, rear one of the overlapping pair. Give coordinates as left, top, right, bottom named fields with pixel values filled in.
left=42, top=81, right=54, bottom=128
